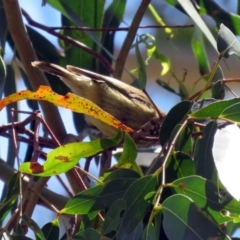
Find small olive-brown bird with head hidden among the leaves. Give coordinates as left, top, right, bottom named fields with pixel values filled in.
left=32, top=61, right=166, bottom=147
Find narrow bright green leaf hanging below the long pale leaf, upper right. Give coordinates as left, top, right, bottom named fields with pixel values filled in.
left=192, top=27, right=210, bottom=76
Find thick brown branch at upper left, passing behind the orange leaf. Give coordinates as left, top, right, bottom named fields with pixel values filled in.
left=3, top=0, right=66, bottom=141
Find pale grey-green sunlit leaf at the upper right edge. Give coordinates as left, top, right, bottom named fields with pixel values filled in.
left=217, top=24, right=240, bottom=58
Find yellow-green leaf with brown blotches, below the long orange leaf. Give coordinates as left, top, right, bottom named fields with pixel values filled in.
left=19, top=132, right=122, bottom=177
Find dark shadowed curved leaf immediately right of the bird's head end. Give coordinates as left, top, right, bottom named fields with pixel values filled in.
left=160, top=101, right=191, bottom=146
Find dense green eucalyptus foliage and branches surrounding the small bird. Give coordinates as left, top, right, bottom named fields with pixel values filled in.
left=0, top=0, right=240, bottom=240
